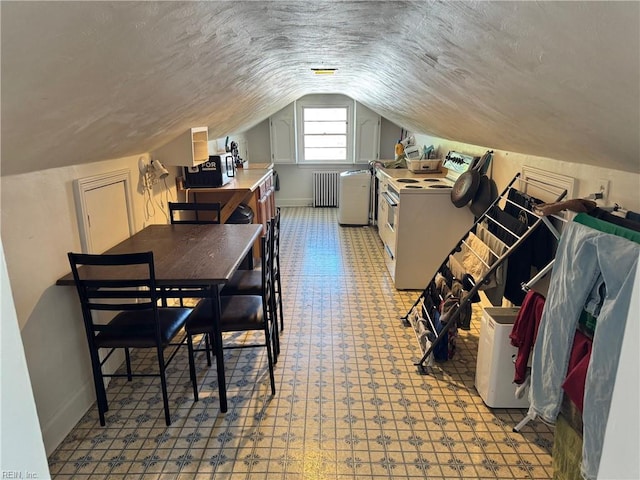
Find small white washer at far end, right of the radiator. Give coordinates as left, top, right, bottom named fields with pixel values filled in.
left=338, top=170, right=371, bottom=225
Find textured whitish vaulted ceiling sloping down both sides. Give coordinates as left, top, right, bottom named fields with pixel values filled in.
left=0, top=1, right=640, bottom=175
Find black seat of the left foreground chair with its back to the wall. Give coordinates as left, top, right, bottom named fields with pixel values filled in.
left=95, top=308, right=191, bottom=348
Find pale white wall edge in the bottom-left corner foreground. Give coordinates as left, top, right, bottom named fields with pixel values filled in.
left=0, top=246, right=49, bottom=478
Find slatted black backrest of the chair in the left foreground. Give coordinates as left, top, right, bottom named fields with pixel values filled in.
left=68, top=252, right=159, bottom=334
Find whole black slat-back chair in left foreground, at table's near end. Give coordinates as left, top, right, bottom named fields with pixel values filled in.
left=68, top=252, right=198, bottom=426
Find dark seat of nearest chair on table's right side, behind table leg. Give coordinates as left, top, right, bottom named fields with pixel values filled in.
left=186, top=295, right=264, bottom=335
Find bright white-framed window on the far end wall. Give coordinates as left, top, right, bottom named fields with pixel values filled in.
left=297, top=95, right=353, bottom=164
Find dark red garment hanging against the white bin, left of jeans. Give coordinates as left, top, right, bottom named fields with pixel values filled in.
left=509, top=290, right=545, bottom=384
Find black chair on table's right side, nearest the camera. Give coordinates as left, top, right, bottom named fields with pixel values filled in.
left=186, top=231, right=277, bottom=395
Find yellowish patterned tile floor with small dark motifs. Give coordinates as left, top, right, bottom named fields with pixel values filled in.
left=49, top=208, right=553, bottom=480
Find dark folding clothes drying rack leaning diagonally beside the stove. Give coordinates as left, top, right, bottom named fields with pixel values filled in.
left=401, top=173, right=567, bottom=375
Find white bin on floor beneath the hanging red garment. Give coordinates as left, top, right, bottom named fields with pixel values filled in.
left=475, top=307, right=529, bottom=408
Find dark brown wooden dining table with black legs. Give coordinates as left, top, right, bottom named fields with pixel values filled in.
left=56, top=224, right=262, bottom=412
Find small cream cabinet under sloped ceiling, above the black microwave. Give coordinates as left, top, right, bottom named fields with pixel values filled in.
left=152, top=127, right=209, bottom=167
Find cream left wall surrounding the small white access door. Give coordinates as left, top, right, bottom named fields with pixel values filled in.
left=0, top=155, right=178, bottom=454
